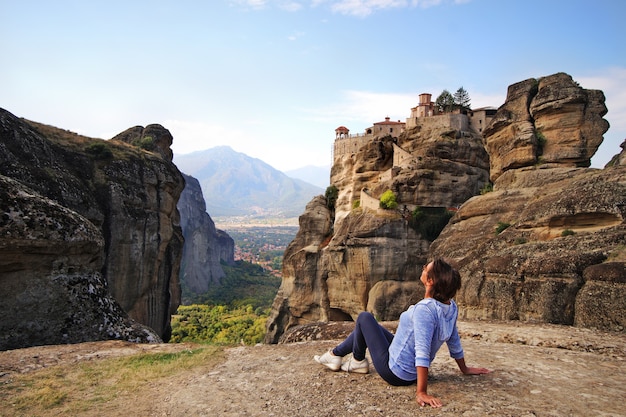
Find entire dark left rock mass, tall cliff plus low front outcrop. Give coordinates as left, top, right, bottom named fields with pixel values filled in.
left=0, top=109, right=184, bottom=349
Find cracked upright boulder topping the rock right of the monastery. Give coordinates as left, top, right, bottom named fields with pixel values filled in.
left=483, top=73, right=609, bottom=181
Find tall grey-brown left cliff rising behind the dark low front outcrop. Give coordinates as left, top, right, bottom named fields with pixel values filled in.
left=0, top=110, right=184, bottom=348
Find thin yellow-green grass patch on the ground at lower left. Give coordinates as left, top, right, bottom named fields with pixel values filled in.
left=0, top=345, right=224, bottom=416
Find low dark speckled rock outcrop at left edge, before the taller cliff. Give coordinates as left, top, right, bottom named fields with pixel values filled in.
left=0, top=175, right=161, bottom=350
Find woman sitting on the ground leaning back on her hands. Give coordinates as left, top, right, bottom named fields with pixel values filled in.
left=314, top=259, right=490, bottom=407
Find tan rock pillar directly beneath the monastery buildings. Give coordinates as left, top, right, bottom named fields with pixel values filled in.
left=266, top=112, right=489, bottom=343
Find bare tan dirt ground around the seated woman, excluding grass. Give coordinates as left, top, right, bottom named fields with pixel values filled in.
left=0, top=322, right=626, bottom=417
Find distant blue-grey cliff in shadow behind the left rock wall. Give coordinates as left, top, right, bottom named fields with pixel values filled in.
left=177, top=174, right=235, bottom=294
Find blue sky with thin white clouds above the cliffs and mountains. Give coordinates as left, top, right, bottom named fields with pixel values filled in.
left=0, top=0, right=626, bottom=170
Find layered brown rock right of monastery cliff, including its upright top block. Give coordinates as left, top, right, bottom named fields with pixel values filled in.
left=431, top=74, right=626, bottom=331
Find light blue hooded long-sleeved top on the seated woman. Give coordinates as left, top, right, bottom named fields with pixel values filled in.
left=389, top=298, right=463, bottom=381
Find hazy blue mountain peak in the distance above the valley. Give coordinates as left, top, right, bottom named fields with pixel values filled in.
left=174, top=146, right=324, bottom=218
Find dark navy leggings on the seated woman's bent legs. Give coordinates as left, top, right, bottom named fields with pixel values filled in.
left=333, top=311, right=415, bottom=386
